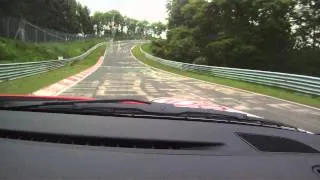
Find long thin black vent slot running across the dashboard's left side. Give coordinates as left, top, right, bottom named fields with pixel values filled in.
left=0, top=130, right=223, bottom=150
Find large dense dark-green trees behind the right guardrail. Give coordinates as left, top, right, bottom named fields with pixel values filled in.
left=152, top=0, right=320, bottom=76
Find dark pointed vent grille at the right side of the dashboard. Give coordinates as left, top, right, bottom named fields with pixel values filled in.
left=237, top=133, right=319, bottom=153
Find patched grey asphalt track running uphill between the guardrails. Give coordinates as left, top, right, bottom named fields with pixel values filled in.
left=62, top=41, right=320, bottom=133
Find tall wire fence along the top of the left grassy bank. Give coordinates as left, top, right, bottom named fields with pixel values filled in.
left=0, top=17, right=95, bottom=42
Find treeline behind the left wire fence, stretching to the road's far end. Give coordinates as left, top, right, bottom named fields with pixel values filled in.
left=0, top=0, right=166, bottom=39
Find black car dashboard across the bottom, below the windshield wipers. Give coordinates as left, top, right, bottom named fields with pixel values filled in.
left=0, top=110, right=320, bottom=180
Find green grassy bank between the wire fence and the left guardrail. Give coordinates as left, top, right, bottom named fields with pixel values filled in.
left=0, top=37, right=103, bottom=63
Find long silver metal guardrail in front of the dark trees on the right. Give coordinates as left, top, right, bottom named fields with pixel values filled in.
left=140, top=46, right=320, bottom=96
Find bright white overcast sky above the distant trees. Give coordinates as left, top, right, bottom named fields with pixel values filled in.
left=77, top=0, right=167, bottom=23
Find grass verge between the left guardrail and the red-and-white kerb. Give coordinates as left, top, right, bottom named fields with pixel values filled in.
left=0, top=46, right=105, bottom=94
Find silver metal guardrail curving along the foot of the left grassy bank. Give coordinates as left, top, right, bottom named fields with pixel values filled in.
left=0, top=42, right=106, bottom=82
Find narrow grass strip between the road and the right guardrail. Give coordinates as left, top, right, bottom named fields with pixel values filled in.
left=132, top=45, right=320, bottom=108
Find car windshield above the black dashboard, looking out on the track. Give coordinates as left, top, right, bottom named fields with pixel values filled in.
left=0, top=0, right=320, bottom=132
